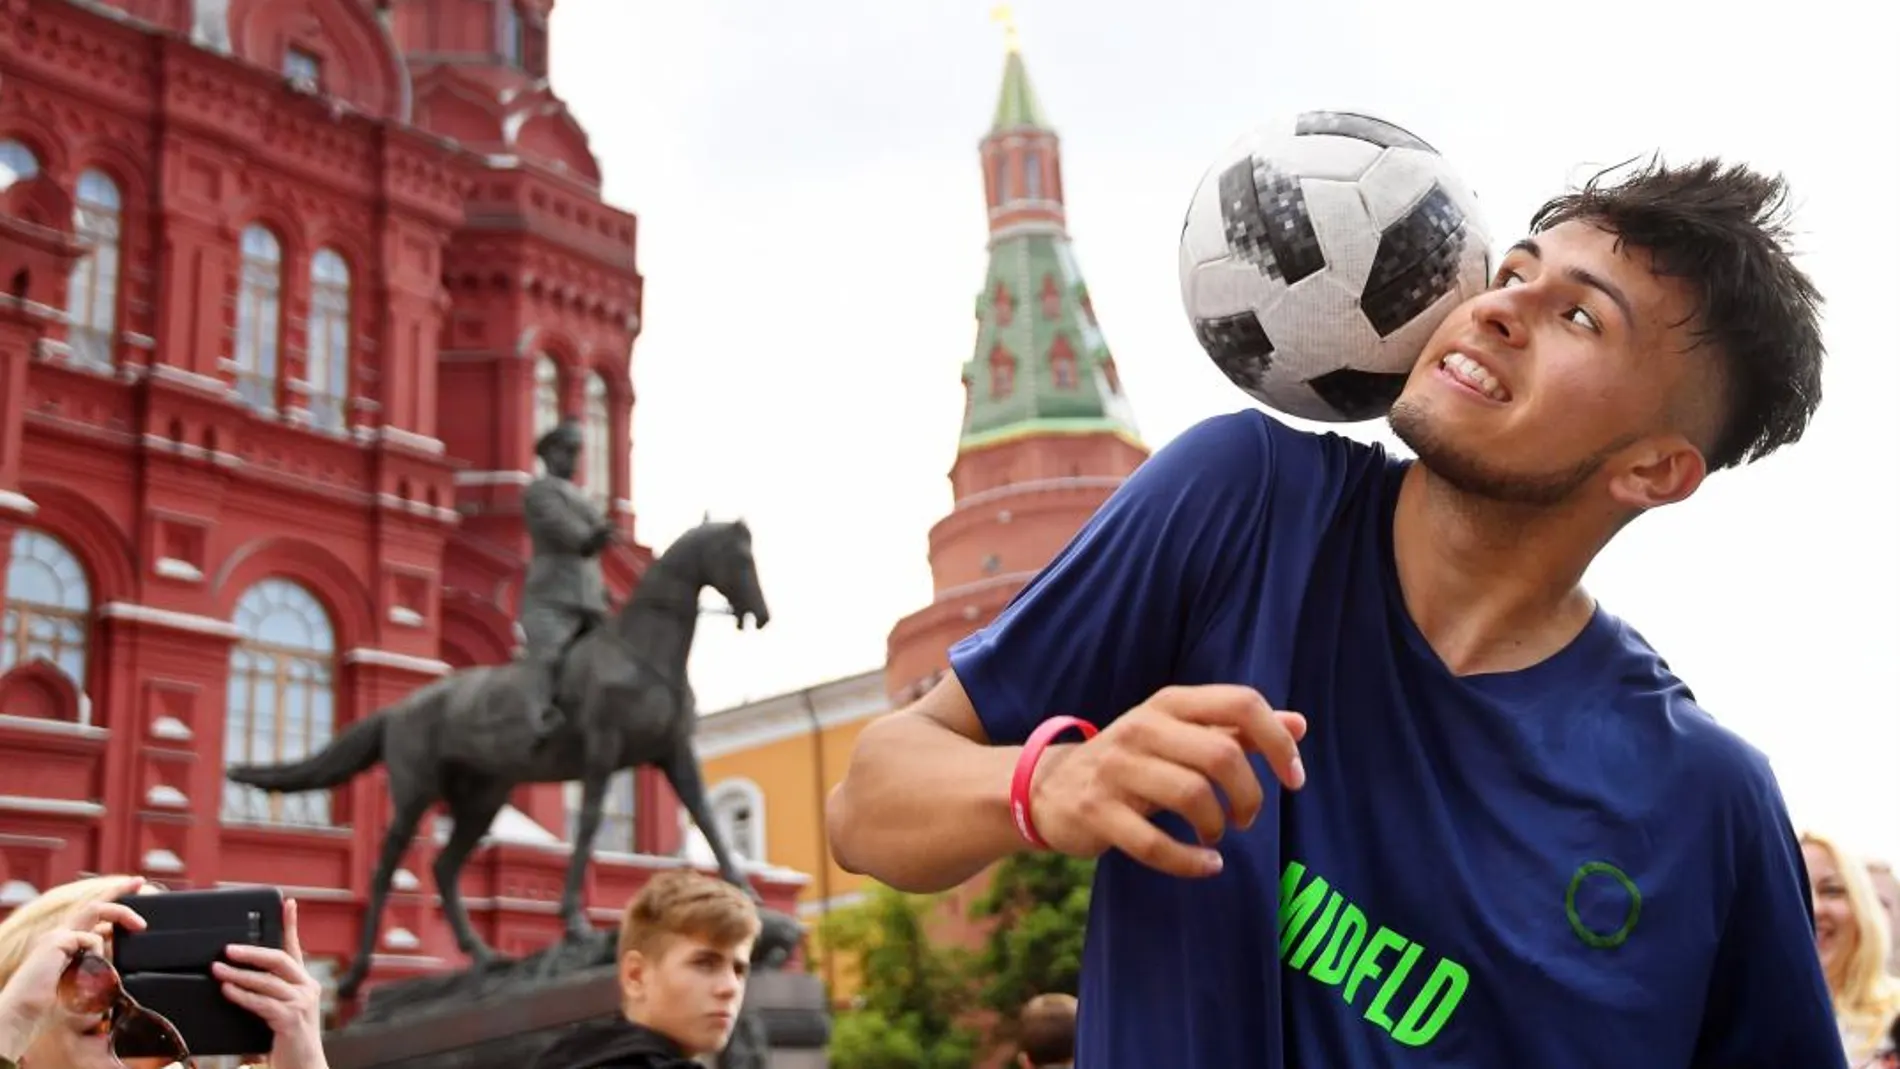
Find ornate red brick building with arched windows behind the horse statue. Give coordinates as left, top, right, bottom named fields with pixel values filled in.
left=0, top=0, right=792, bottom=1002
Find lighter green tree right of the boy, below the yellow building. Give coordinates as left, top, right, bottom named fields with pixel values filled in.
left=819, top=887, right=977, bottom=1069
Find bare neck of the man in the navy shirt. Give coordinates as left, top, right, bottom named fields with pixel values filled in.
left=1393, top=463, right=1613, bottom=676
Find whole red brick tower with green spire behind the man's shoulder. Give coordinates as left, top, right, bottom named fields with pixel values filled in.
left=885, top=20, right=1148, bottom=706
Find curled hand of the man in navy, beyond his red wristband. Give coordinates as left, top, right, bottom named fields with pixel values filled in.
left=1030, top=684, right=1307, bottom=875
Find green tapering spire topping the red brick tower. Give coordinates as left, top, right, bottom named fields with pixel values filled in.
left=958, top=34, right=1140, bottom=468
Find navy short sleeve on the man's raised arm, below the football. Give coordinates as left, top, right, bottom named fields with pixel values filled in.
left=950, top=412, right=1294, bottom=744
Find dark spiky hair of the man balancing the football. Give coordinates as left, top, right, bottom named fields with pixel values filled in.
left=1531, top=158, right=1826, bottom=471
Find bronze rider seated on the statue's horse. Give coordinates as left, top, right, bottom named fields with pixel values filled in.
left=515, top=418, right=614, bottom=739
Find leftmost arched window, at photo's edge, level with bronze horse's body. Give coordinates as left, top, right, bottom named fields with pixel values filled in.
left=0, top=528, right=93, bottom=691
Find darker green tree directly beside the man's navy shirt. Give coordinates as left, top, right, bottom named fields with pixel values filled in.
left=971, top=851, right=1094, bottom=1039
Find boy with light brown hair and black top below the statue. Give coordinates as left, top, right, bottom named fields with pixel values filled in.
left=534, top=872, right=760, bottom=1069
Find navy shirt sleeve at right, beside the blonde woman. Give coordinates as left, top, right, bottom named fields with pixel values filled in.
left=1695, top=752, right=1847, bottom=1069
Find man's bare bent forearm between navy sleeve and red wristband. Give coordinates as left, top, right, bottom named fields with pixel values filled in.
left=825, top=714, right=1024, bottom=892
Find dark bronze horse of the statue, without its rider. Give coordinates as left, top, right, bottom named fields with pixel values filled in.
left=224, top=520, right=770, bottom=997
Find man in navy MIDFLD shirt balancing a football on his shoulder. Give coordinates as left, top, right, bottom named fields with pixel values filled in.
left=828, top=161, right=1843, bottom=1069
